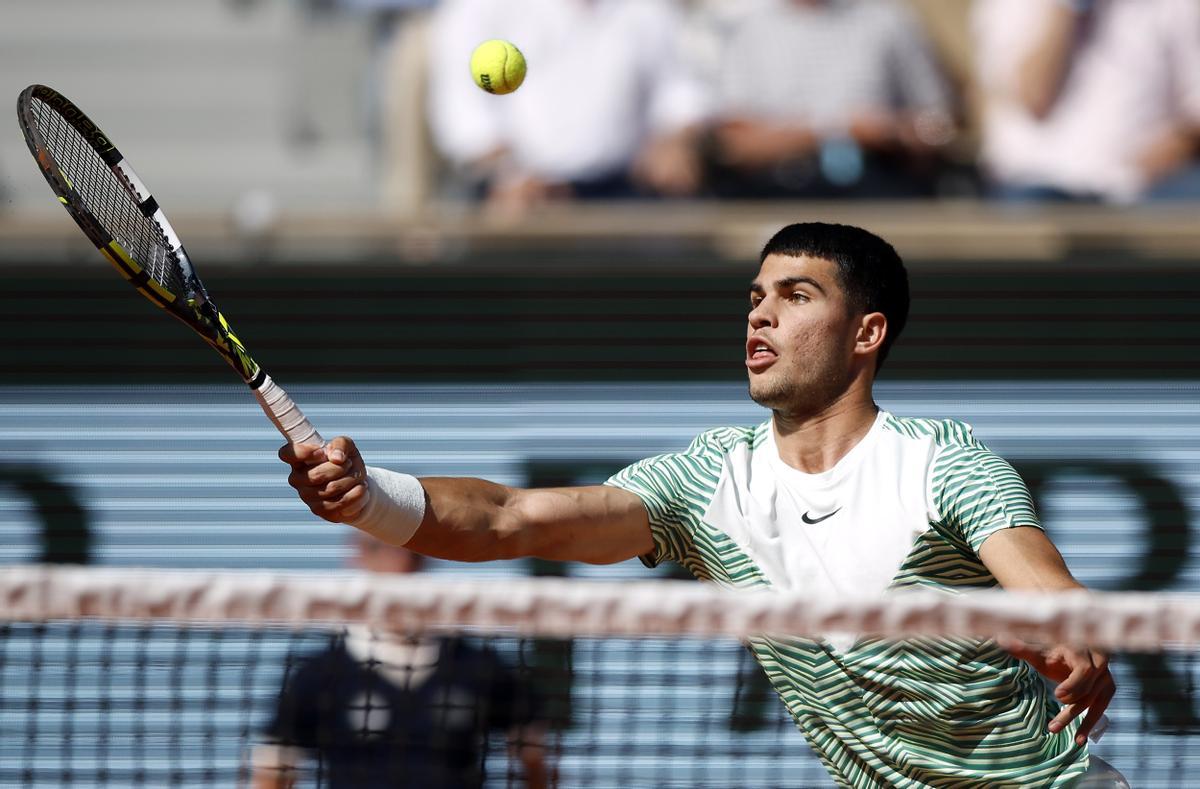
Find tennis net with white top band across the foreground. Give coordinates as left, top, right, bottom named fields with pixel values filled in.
left=0, top=567, right=1200, bottom=788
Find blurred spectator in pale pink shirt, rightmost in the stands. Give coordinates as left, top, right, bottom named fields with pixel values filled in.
left=973, top=0, right=1200, bottom=201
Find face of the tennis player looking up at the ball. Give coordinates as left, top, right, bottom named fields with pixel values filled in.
left=745, top=254, right=860, bottom=414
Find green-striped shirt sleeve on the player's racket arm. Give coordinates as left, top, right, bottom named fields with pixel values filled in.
left=605, top=433, right=722, bottom=567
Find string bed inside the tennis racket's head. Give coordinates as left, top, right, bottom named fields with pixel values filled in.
left=32, top=100, right=187, bottom=296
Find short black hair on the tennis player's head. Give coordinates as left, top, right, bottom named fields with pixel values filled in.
left=758, top=222, right=908, bottom=371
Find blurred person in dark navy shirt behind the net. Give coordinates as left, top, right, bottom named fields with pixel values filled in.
left=253, top=532, right=548, bottom=789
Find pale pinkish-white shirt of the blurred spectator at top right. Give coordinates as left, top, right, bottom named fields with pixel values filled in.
left=972, top=0, right=1200, bottom=201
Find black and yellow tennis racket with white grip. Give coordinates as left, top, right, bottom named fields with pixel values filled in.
left=17, top=85, right=325, bottom=445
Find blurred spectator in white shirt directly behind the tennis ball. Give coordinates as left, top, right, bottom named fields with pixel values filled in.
left=428, top=0, right=708, bottom=210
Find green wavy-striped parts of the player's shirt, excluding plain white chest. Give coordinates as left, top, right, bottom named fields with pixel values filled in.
left=608, top=415, right=1087, bottom=789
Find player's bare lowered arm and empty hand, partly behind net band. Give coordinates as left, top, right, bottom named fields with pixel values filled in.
left=979, top=528, right=1116, bottom=745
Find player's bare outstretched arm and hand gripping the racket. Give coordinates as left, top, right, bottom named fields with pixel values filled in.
left=280, top=436, right=654, bottom=564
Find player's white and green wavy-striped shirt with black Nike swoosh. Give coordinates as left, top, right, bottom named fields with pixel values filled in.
left=607, top=411, right=1087, bottom=789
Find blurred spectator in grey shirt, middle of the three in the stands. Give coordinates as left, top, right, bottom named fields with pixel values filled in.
left=708, top=0, right=954, bottom=198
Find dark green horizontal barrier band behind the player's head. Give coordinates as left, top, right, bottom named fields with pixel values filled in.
left=0, top=260, right=1200, bottom=384
